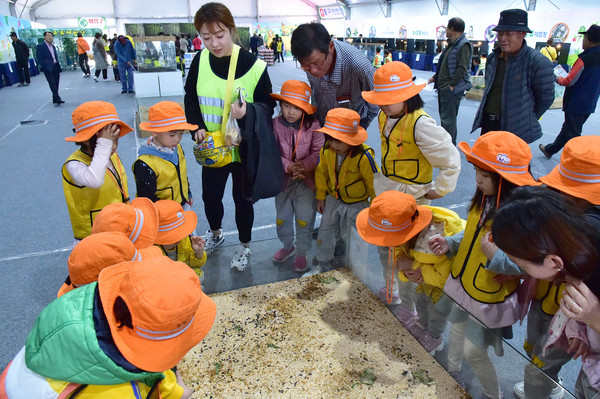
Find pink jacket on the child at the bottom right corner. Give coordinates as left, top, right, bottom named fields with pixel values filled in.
left=544, top=310, right=600, bottom=391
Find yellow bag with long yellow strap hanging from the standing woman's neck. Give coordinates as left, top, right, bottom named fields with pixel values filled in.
left=194, top=44, right=240, bottom=168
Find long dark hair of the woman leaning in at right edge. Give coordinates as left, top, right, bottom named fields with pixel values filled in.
left=492, top=186, right=600, bottom=295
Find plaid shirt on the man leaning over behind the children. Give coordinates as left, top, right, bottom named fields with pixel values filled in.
left=306, top=40, right=379, bottom=129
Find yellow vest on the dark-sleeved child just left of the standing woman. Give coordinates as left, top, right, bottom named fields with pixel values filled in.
left=132, top=144, right=190, bottom=205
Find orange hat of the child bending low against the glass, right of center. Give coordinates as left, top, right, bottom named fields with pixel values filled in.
left=356, top=190, right=433, bottom=247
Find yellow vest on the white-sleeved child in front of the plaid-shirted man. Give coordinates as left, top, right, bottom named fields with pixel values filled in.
left=378, top=109, right=433, bottom=184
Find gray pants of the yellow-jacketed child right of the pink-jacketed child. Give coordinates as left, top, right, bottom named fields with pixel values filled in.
left=317, top=194, right=369, bottom=266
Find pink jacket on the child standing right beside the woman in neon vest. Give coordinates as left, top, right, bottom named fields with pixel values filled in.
left=273, top=116, right=325, bottom=191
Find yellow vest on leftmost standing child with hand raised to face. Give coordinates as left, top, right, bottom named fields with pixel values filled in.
left=62, top=149, right=129, bottom=240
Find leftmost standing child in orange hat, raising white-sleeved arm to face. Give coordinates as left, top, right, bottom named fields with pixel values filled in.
left=62, top=101, right=133, bottom=242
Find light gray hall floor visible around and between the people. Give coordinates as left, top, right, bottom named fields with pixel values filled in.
left=0, top=60, right=600, bottom=397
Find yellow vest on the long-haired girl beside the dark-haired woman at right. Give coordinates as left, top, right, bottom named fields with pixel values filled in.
left=451, top=208, right=519, bottom=303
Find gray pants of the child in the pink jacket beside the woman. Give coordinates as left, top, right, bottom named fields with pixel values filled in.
left=275, top=180, right=317, bottom=256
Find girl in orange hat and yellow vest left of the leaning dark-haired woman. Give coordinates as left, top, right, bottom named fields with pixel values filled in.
left=430, top=132, right=539, bottom=399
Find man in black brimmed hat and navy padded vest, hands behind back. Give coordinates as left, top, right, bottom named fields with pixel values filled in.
left=471, top=9, right=554, bottom=143
